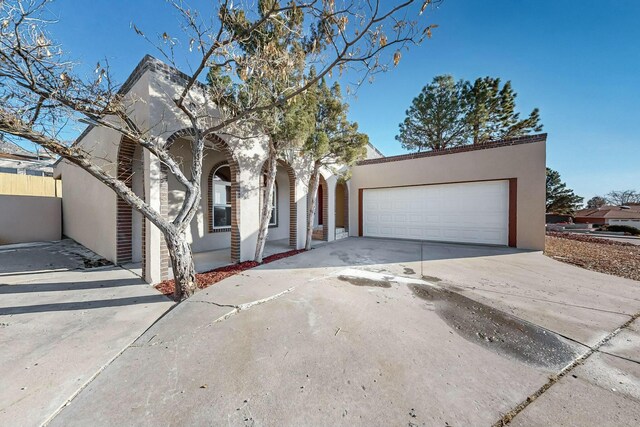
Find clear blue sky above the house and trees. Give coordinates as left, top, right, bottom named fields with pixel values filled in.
left=36, top=0, right=640, bottom=198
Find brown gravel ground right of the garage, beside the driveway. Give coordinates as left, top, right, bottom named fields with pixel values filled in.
left=544, top=233, right=640, bottom=281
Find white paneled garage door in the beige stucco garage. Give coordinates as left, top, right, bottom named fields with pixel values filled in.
left=362, top=181, right=509, bottom=245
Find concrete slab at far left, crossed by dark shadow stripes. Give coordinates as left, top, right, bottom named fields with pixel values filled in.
left=0, top=240, right=173, bottom=426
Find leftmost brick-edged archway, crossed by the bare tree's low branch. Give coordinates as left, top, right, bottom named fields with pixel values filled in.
left=116, top=138, right=146, bottom=273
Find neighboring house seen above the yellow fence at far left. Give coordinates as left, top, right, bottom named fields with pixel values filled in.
left=0, top=135, right=55, bottom=176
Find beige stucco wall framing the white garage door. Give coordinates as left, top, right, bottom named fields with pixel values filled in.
left=349, top=142, right=546, bottom=250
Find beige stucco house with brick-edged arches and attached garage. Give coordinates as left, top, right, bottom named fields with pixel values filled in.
left=55, top=56, right=546, bottom=282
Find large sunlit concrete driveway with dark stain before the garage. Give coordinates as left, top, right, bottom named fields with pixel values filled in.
left=38, top=238, right=640, bottom=426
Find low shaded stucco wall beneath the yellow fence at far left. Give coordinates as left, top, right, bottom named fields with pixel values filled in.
left=0, top=195, right=62, bottom=245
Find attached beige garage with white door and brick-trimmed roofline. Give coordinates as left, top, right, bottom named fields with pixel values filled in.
left=349, top=134, right=547, bottom=251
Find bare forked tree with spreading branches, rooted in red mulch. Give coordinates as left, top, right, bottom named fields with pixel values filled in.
left=0, top=0, right=434, bottom=299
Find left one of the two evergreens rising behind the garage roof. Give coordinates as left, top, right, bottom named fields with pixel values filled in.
left=396, top=75, right=467, bottom=152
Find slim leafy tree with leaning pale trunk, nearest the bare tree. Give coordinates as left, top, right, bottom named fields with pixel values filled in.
left=207, top=0, right=317, bottom=262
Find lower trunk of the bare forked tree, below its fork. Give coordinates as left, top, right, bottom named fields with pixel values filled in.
left=164, top=232, right=196, bottom=301
